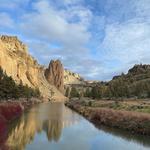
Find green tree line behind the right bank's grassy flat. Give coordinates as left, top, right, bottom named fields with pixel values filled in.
left=66, top=77, right=150, bottom=99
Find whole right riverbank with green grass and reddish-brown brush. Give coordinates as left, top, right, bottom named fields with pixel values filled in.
left=65, top=99, right=150, bottom=135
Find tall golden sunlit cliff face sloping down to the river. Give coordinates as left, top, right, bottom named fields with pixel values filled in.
left=0, top=36, right=65, bottom=100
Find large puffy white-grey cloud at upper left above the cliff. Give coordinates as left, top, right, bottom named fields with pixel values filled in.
left=21, top=1, right=90, bottom=48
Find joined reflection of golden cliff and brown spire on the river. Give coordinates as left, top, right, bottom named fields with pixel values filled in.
left=6, top=103, right=80, bottom=150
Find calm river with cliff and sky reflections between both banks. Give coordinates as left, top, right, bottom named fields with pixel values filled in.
left=6, top=103, right=150, bottom=150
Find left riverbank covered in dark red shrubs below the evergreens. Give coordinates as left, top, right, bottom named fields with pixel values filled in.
left=0, top=98, right=41, bottom=145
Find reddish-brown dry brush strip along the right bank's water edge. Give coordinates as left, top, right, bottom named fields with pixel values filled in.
left=90, top=108, right=150, bottom=135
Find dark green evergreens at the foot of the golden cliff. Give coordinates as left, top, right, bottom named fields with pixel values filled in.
left=0, top=67, right=40, bottom=100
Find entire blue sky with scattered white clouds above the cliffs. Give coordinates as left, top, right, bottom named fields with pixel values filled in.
left=0, top=0, right=150, bottom=80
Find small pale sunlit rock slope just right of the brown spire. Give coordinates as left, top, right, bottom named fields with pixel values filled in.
left=64, top=69, right=85, bottom=85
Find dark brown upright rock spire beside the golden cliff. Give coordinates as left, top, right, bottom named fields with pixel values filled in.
left=45, top=60, right=64, bottom=93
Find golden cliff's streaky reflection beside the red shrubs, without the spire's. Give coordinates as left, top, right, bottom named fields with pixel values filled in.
left=7, top=113, right=41, bottom=150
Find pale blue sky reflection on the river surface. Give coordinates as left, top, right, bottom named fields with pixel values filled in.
left=26, top=116, right=149, bottom=150
